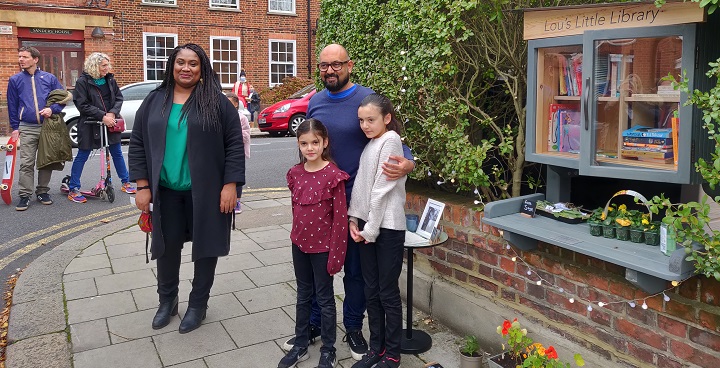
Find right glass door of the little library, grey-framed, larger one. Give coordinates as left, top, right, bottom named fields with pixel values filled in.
left=581, top=26, right=694, bottom=182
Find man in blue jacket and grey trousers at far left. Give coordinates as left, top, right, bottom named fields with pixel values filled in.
left=7, top=46, right=65, bottom=211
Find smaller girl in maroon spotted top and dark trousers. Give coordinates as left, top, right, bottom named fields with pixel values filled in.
left=278, top=119, right=349, bottom=368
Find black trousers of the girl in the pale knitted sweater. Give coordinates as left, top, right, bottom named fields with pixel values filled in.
left=359, top=221, right=405, bottom=359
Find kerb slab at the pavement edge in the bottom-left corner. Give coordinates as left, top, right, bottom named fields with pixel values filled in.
left=5, top=331, right=71, bottom=368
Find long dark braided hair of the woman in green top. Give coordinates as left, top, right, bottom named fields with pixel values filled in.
left=157, top=43, right=222, bottom=132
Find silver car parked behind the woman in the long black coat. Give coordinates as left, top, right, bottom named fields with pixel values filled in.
left=63, top=81, right=250, bottom=147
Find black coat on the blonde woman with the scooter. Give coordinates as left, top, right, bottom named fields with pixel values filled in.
left=73, top=73, right=123, bottom=150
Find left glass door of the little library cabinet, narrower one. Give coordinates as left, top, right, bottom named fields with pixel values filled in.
left=527, top=36, right=583, bottom=168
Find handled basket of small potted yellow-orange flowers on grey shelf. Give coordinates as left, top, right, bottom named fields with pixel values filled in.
left=588, top=190, right=659, bottom=245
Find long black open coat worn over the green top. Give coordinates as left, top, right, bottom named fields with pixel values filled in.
left=128, top=89, right=245, bottom=261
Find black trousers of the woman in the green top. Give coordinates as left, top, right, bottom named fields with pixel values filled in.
left=157, top=187, right=217, bottom=308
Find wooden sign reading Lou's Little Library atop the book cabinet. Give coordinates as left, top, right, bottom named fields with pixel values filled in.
left=525, top=2, right=705, bottom=40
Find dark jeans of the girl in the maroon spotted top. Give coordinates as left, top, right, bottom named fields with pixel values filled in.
left=292, top=244, right=337, bottom=352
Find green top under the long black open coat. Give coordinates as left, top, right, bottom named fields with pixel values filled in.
left=160, top=103, right=192, bottom=190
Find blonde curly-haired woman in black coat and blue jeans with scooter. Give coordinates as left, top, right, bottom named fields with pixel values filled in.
left=68, top=52, right=135, bottom=203
